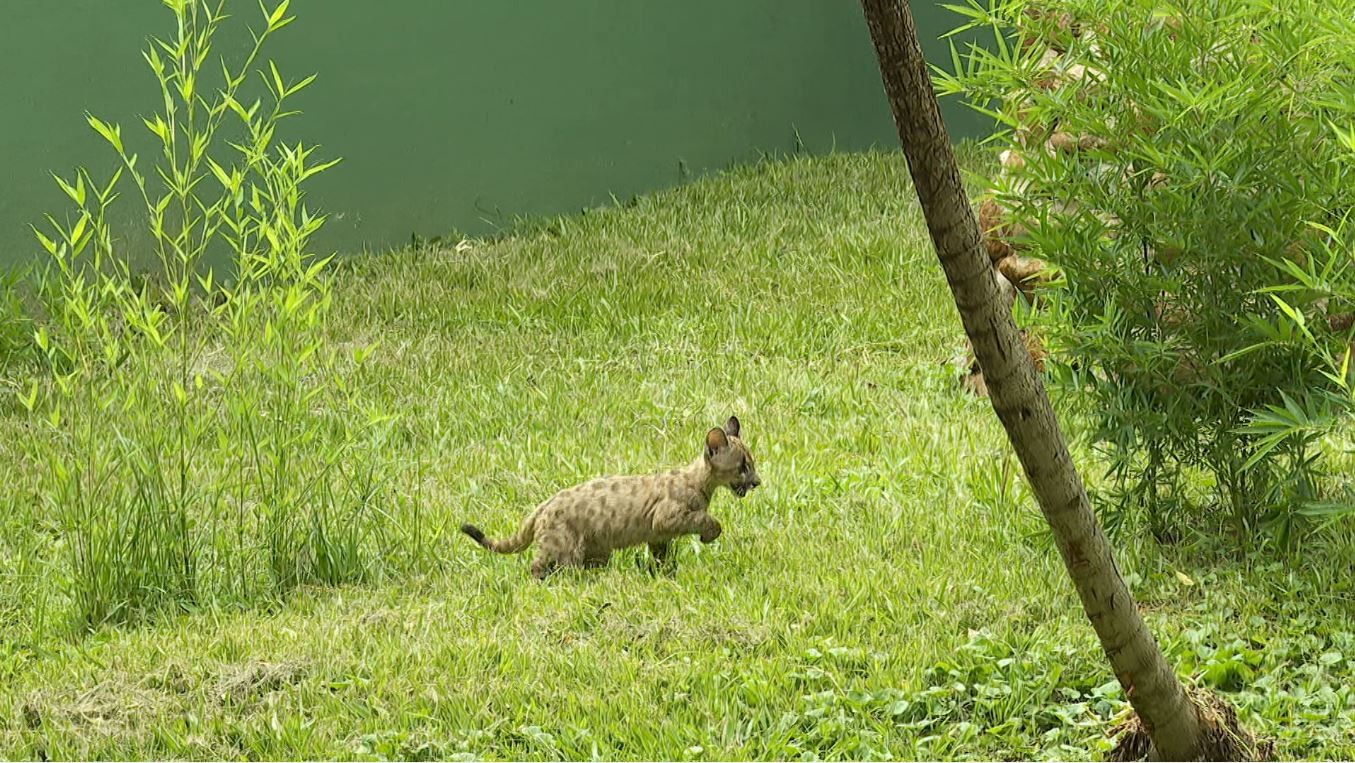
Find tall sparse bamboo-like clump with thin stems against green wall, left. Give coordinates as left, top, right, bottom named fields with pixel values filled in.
left=22, top=0, right=393, bottom=627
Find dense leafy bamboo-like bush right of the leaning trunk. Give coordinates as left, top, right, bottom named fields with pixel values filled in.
left=939, top=0, right=1355, bottom=541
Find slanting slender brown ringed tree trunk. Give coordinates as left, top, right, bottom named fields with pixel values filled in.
left=862, top=0, right=1202, bottom=760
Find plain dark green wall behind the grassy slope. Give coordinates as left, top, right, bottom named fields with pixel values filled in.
left=0, top=0, right=978, bottom=263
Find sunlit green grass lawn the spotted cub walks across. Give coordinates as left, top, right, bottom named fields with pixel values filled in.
left=0, top=153, right=1355, bottom=760
